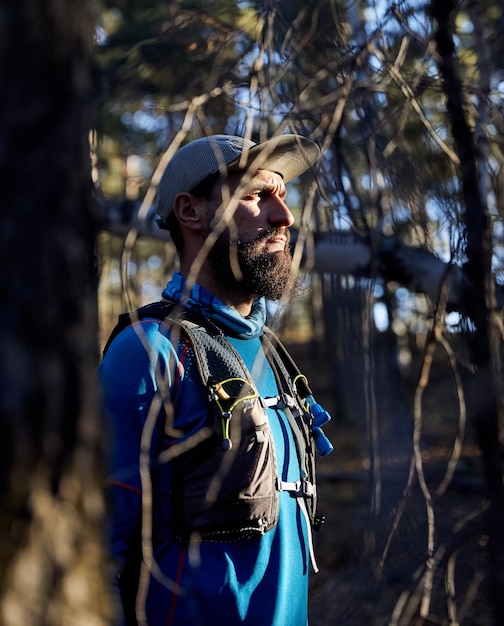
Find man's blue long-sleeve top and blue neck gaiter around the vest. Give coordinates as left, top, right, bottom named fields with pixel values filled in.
left=100, top=274, right=310, bottom=626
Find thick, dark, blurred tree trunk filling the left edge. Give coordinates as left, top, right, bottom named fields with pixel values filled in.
left=0, top=0, right=108, bottom=626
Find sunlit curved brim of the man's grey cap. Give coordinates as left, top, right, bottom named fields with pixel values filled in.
left=228, top=135, right=320, bottom=182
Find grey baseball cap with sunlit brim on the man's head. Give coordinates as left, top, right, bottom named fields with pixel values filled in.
left=157, top=135, right=320, bottom=228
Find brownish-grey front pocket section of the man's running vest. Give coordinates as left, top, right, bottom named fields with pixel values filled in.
left=172, top=388, right=278, bottom=541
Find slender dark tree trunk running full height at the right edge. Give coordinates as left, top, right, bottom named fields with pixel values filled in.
left=431, top=0, right=504, bottom=624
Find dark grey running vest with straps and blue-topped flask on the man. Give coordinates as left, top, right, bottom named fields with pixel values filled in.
left=104, top=301, right=332, bottom=571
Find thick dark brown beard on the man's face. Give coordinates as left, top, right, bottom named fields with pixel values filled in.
left=208, top=229, right=292, bottom=300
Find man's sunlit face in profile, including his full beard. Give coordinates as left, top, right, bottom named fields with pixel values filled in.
left=204, top=170, right=294, bottom=300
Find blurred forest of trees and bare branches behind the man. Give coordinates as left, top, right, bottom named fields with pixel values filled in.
left=2, top=0, right=504, bottom=626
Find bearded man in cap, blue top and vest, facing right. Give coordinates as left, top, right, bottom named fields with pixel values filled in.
left=100, top=135, right=330, bottom=626
